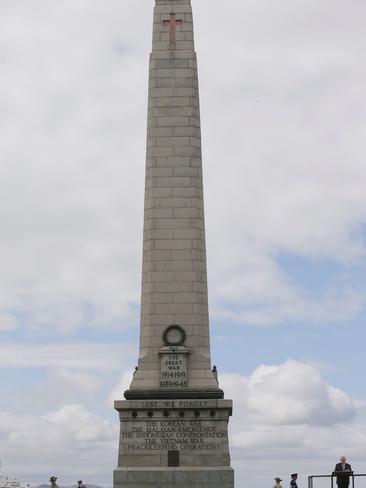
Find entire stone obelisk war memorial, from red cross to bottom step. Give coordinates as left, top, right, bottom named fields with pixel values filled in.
left=114, top=0, right=234, bottom=488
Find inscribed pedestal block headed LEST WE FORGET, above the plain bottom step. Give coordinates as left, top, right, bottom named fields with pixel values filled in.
left=115, top=399, right=232, bottom=467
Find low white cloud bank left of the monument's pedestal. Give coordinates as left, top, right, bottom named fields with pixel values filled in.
left=0, top=404, right=118, bottom=484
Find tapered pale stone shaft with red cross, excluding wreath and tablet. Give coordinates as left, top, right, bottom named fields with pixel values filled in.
left=131, top=0, right=217, bottom=389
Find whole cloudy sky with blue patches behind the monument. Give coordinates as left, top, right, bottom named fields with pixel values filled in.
left=0, top=0, right=366, bottom=488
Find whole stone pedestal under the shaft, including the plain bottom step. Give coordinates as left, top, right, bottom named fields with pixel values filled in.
left=114, top=399, right=234, bottom=488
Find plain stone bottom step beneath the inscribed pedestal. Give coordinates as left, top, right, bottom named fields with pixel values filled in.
left=113, top=466, right=234, bottom=488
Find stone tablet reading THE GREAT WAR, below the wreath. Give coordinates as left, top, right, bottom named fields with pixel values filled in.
left=160, top=352, right=188, bottom=388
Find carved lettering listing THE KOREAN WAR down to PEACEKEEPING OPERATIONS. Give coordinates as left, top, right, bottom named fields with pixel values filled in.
left=121, top=419, right=227, bottom=453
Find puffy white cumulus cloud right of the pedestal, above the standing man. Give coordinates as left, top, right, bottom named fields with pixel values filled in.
left=221, top=360, right=366, bottom=458
